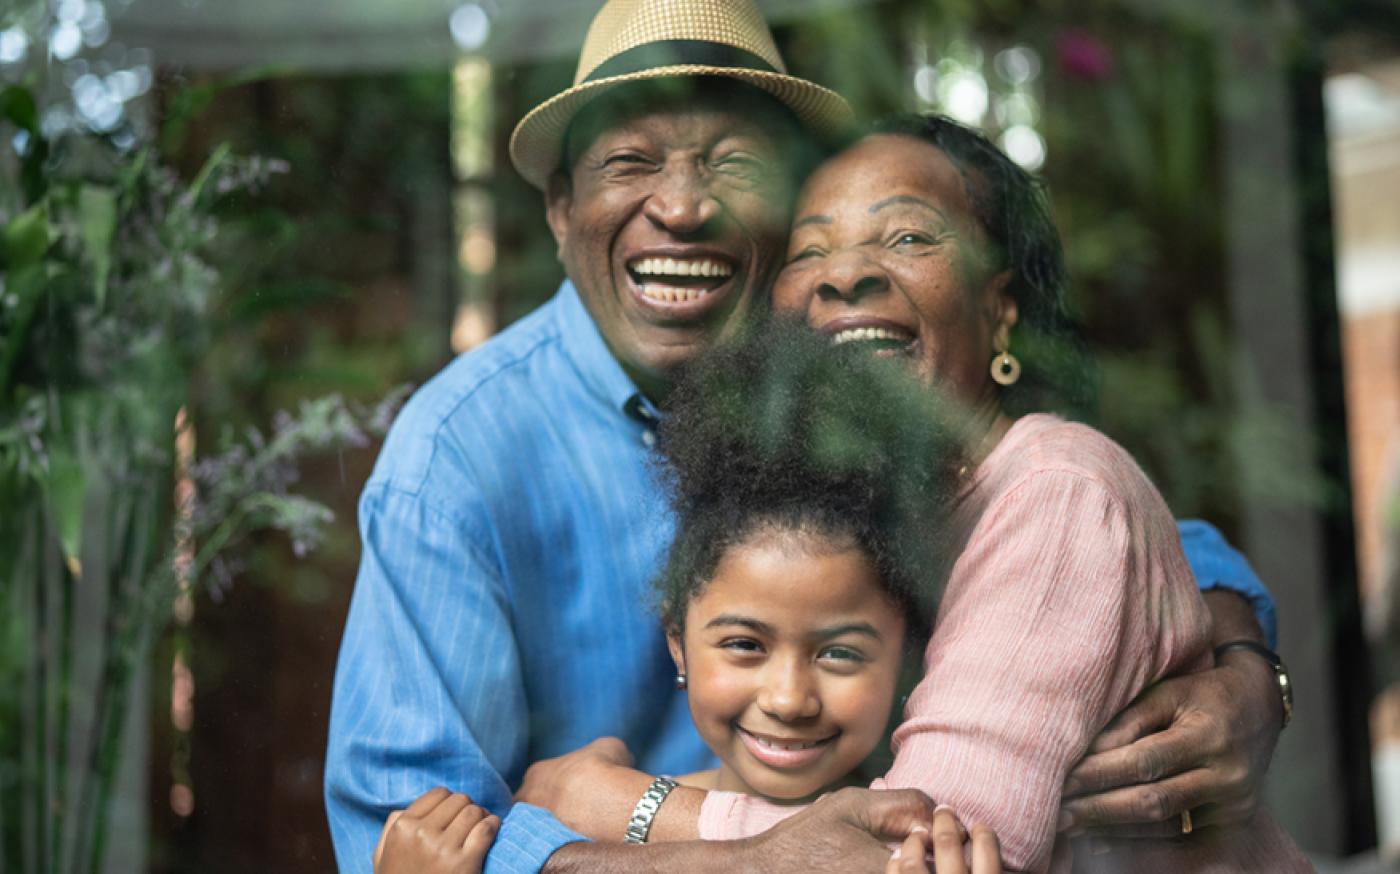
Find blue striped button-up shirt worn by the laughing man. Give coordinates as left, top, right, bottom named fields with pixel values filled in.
left=326, top=282, right=1271, bottom=874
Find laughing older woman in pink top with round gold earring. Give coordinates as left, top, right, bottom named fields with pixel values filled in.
left=525, top=116, right=1309, bottom=871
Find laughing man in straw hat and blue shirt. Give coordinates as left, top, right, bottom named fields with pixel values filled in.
left=326, top=0, right=1282, bottom=871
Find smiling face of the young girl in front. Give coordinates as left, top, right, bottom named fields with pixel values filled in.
left=671, top=529, right=904, bottom=800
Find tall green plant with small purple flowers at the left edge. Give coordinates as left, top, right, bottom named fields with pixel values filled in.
left=0, top=74, right=396, bottom=871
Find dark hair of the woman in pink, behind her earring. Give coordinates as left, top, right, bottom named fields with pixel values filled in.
left=851, top=113, right=1098, bottom=417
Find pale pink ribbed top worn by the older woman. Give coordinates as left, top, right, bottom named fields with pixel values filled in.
left=700, top=415, right=1312, bottom=873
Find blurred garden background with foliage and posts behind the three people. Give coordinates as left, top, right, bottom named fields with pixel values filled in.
left=0, top=0, right=1400, bottom=873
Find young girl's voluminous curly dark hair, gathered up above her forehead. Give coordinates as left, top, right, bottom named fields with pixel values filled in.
left=657, top=318, right=962, bottom=651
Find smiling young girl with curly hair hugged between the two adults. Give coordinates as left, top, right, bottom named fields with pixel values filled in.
left=377, top=324, right=1000, bottom=873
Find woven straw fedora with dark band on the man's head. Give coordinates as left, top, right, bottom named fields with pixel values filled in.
left=511, top=0, right=851, bottom=189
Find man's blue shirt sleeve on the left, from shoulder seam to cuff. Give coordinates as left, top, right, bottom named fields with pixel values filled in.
left=325, top=485, right=582, bottom=874
